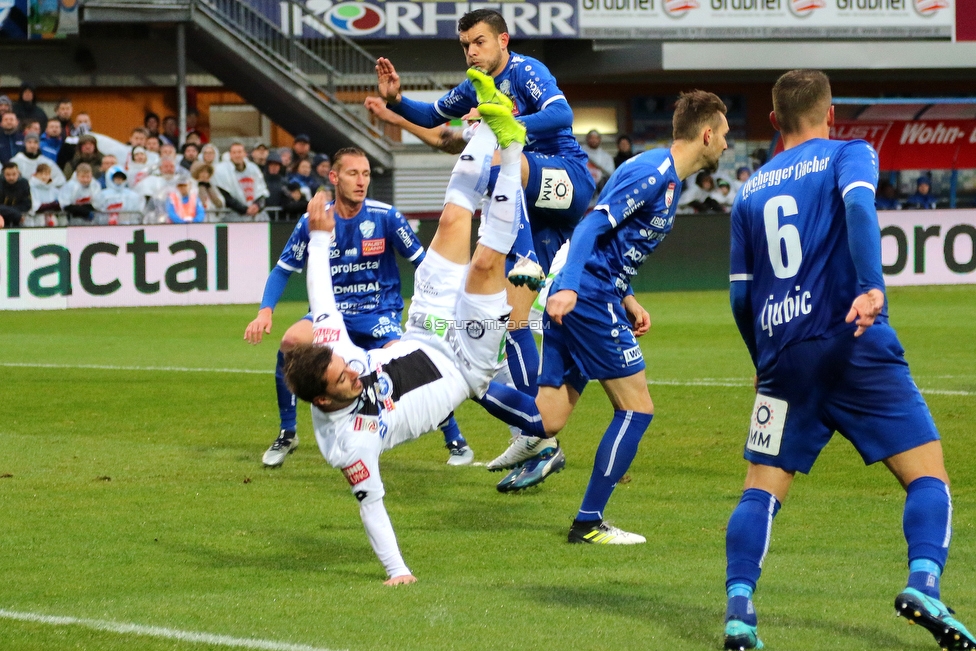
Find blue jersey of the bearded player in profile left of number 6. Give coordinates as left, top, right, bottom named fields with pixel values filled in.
left=551, top=148, right=681, bottom=300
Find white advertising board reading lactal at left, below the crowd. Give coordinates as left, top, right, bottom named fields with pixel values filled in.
left=0, top=224, right=269, bottom=310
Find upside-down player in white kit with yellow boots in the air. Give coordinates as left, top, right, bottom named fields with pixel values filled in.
left=285, top=107, right=525, bottom=585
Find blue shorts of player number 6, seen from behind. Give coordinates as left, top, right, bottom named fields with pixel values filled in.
left=744, top=322, right=939, bottom=473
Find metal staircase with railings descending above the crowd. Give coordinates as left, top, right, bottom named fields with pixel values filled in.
left=82, top=0, right=439, bottom=168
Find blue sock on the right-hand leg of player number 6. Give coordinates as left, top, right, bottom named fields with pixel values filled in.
left=902, top=477, right=952, bottom=599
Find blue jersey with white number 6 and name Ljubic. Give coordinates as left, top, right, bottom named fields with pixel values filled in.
left=730, top=139, right=887, bottom=369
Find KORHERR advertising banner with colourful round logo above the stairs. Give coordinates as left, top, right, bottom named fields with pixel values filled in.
left=264, top=0, right=577, bottom=40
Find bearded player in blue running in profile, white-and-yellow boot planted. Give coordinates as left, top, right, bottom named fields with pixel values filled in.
left=480, top=91, right=729, bottom=545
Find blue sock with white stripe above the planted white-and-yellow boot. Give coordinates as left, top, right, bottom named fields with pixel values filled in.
left=576, top=409, right=654, bottom=522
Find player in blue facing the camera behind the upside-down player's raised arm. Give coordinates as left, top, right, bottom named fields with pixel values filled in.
left=244, top=147, right=474, bottom=468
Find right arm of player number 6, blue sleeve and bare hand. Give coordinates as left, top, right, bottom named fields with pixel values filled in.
left=835, top=141, right=885, bottom=337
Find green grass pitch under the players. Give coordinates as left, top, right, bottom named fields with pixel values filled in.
left=0, top=287, right=976, bottom=651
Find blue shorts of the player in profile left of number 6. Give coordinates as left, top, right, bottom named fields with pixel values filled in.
left=539, top=296, right=645, bottom=393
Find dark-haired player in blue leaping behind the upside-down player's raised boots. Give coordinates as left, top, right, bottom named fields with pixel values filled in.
left=366, top=9, right=595, bottom=487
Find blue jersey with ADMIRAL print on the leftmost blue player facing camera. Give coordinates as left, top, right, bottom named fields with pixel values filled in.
left=278, top=199, right=424, bottom=314
